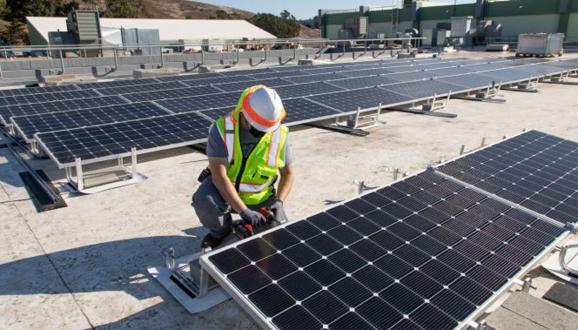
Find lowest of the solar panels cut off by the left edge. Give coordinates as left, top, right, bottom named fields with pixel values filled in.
left=0, top=96, right=127, bottom=125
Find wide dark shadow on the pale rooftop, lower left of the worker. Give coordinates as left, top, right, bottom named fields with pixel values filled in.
left=0, top=235, right=200, bottom=299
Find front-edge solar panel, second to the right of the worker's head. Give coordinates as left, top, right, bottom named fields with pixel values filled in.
left=308, top=87, right=412, bottom=112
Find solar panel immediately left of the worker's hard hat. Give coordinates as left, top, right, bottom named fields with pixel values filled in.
left=156, top=92, right=240, bottom=112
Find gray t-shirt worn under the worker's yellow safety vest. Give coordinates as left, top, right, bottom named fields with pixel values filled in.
left=207, top=125, right=293, bottom=166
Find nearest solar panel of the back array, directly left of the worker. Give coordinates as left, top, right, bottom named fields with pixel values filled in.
left=35, top=113, right=211, bottom=167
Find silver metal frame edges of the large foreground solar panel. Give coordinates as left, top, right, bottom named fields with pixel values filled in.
left=200, top=168, right=570, bottom=329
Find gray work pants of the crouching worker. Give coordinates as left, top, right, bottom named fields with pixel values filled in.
left=191, top=176, right=275, bottom=237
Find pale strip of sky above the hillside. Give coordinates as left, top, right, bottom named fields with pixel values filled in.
left=199, top=0, right=475, bottom=19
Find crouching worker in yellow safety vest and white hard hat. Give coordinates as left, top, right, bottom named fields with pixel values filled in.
left=192, top=85, right=294, bottom=248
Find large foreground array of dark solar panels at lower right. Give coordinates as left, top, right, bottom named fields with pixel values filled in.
left=201, top=131, right=578, bottom=330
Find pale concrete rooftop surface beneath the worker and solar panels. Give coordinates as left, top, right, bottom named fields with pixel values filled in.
left=0, top=53, right=578, bottom=329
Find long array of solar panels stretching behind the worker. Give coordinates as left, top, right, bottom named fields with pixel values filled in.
left=0, top=58, right=578, bottom=167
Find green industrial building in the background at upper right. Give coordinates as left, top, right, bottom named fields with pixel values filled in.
left=319, top=0, right=578, bottom=41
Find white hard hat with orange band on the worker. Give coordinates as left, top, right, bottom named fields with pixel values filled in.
left=242, top=86, right=286, bottom=132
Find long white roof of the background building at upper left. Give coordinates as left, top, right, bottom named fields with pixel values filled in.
left=26, top=16, right=276, bottom=41
